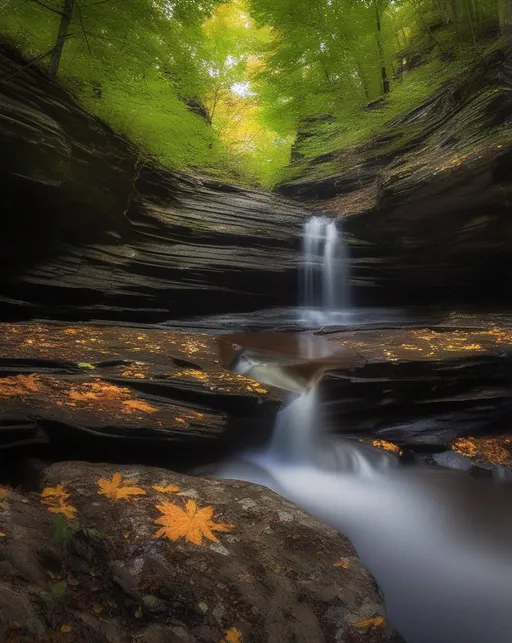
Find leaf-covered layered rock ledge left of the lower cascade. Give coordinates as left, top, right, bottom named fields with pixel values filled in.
left=0, top=323, right=281, bottom=477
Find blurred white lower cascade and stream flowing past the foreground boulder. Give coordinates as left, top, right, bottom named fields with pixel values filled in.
left=216, top=388, right=512, bottom=643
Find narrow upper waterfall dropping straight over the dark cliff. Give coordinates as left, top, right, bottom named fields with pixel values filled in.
left=301, top=216, right=350, bottom=325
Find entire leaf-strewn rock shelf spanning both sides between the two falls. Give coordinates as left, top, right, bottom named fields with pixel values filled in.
left=0, top=316, right=512, bottom=480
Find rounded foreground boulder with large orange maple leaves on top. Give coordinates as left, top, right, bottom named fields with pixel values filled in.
left=0, top=462, right=398, bottom=643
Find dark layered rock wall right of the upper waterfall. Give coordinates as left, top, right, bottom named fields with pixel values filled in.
left=279, top=50, right=512, bottom=305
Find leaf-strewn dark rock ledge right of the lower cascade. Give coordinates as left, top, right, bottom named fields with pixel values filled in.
left=220, top=317, right=512, bottom=450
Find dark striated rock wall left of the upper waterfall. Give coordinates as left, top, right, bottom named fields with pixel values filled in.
left=0, top=49, right=307, bottom=321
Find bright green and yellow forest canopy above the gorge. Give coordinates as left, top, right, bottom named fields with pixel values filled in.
left=0, top=0, right=510, bottom=187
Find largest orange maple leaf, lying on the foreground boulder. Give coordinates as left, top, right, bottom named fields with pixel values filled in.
left=153, top=500, right=235, bottom=545
